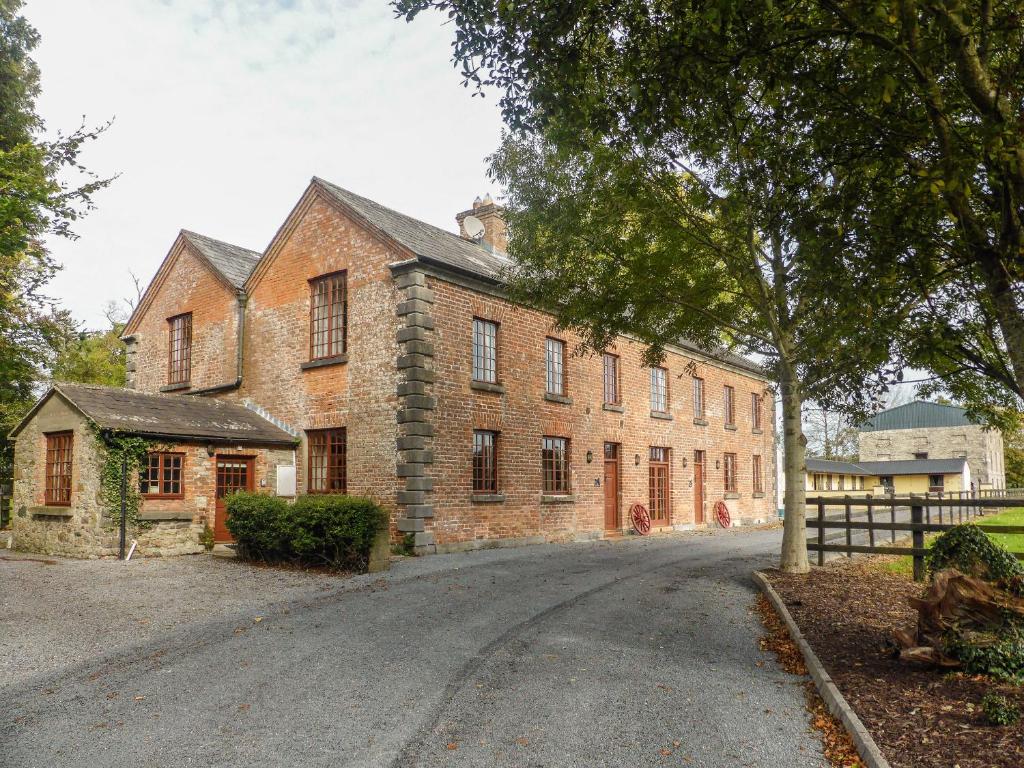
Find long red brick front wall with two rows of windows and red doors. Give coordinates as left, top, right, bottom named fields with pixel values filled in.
left=428, top=279, right=775, bottom=546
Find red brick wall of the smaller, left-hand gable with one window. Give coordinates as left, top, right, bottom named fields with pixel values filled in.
left=127, top=244, right=238, bottom=392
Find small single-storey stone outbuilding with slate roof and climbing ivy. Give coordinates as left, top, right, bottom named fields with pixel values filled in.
left=11, top=384, right=297, bottom=557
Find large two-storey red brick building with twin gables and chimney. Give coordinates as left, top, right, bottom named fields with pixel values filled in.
left=12, top=178, right=775, bottom=551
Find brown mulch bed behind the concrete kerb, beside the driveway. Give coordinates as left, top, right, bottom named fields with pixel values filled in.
left=765, top=558, right=1024, bottom=768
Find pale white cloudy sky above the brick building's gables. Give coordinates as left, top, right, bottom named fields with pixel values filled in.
left=32, top=0, right=502, bottom=328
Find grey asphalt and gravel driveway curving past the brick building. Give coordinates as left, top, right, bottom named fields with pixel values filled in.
left=0, top=530, right=822, bottom=768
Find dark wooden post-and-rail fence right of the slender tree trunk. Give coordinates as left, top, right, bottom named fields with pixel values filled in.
left=807, top=496, right=1024, bottom=582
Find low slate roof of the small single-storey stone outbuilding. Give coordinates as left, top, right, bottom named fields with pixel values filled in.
left=11, top=383, right=295, bottom=445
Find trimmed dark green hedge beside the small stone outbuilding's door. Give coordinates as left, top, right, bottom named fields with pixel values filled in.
left=225, top=494, right=387, bottom=570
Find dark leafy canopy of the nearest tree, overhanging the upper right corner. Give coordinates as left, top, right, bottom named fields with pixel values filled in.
left=394, top=0, right=1024, bottom=428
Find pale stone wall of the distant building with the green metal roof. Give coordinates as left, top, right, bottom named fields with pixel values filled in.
left=857, top=425, right=1006, bottom=488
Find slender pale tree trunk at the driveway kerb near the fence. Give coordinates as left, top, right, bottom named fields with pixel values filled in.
left=779, top=361, right=810, bottom=573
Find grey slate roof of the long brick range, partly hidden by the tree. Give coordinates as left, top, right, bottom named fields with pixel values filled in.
left=313, top=176, right=765, bottom=376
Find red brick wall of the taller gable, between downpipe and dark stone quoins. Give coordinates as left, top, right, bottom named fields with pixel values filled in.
left=232, top=196, right=407, bottom=518
